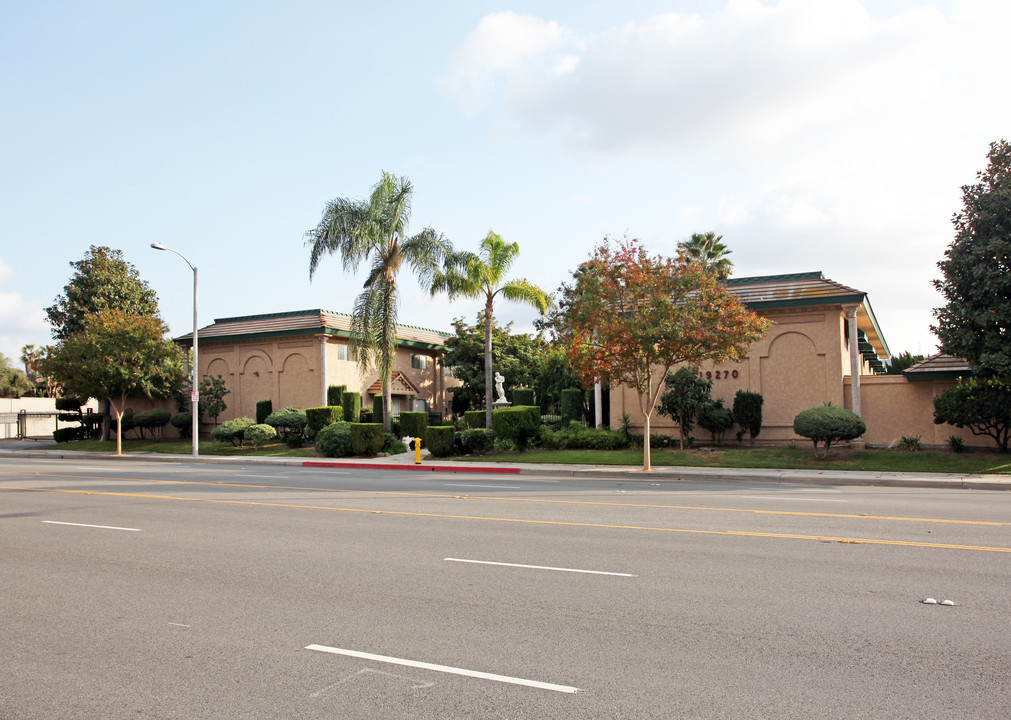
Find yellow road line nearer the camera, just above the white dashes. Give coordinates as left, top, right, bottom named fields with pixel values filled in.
left=0, top=485, right=1011, bottom=553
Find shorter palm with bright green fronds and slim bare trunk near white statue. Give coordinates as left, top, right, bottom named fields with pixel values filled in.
left=431, top=231, right=551, bottom=428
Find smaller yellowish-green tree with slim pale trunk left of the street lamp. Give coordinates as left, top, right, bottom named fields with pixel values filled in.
left=42, top=309, right=186, bottom=455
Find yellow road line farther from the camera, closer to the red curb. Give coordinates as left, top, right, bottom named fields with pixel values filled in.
left=0, top=472, right=1011, bottom=528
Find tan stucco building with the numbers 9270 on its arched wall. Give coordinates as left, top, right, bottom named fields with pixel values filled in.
left=611, top=272, right=988, bottom=446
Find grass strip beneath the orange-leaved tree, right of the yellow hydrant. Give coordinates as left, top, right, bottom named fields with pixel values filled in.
left=456, top=448, right=1011, bottom=474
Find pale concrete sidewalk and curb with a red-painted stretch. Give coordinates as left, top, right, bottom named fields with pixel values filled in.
left=0, top=440, right=1011, bottom=490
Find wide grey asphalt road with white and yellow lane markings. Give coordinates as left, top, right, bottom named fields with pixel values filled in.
left=0, top=458, right=1011, bottom=720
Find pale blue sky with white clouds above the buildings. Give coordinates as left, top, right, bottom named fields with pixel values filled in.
left=0, top=0, right=1011, bottom=368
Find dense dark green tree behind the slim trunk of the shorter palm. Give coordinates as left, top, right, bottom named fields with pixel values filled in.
left=443, top=316, right=546, bottom=412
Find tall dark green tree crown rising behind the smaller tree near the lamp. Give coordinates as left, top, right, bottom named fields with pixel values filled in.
left=45, top=245, right=158, bottom=340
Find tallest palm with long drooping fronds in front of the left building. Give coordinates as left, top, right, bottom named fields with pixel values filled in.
left=305, top=172, right=453, bottom=432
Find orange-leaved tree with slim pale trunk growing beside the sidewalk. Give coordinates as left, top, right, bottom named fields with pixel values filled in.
left=552, top=238, right=770, bottom=470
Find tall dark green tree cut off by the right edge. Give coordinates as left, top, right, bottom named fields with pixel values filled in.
left=931, top=140, right=1011, bottom=379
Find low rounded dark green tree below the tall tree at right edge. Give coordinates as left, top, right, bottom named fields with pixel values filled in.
left=934, top=377, right=1011, bottom=452
